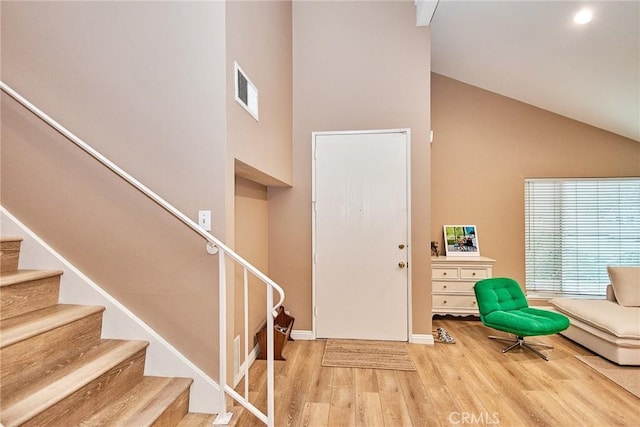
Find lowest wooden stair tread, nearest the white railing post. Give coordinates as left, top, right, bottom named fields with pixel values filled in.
left=80, top=376, right=193, bottom=426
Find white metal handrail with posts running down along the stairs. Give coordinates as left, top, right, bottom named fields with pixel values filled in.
left=0, top=80, right=284, bottom=426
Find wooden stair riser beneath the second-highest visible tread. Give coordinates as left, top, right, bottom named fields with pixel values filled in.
left=0, top=312, right=102, bottom=400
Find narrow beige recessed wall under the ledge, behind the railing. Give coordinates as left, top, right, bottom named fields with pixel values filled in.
left=233, top=177, right=269, bottom=363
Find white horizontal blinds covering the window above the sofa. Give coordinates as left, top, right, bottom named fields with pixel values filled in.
left=525, top=178, right=640, bottom=296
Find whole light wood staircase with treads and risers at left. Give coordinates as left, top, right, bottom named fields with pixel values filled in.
left=0, top=238, right=220, bottom=427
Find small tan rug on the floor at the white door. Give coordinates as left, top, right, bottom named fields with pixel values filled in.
left=322, top=339, right=416, bottom=371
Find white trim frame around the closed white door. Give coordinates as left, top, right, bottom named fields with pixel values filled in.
left=311, top=128, right=414, bottom=343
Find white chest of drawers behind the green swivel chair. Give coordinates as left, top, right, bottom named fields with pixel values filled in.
left=431, top=256, right=496, bottom=316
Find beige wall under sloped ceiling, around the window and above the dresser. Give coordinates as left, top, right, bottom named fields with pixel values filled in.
left=431, top=74, right=640, bottom=284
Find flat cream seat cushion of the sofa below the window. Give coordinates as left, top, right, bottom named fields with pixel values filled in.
left=549, top=298, right=640, bottom=339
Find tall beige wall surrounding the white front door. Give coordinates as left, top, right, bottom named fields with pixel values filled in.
left=269, top=1, right=431, bottom=334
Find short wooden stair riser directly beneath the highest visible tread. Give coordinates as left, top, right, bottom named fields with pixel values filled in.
left=0, top=276, right=60, bottom=320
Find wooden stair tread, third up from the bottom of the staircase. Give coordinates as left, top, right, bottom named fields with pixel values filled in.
left=0, top=304, right=104, bottom=348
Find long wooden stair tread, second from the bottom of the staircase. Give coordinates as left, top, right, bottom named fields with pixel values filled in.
left=2, top=340, right=148, bottom=425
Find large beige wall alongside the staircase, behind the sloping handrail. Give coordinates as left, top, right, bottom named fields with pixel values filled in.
left=0, top=2, right=226, bottom=377
